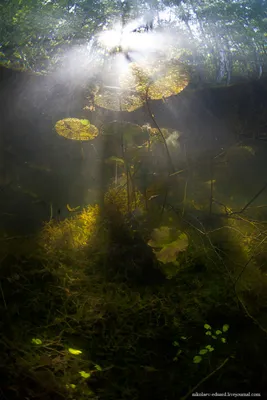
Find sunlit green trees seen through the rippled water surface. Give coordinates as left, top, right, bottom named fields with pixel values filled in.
left=0, top=0, right=267, bottom=83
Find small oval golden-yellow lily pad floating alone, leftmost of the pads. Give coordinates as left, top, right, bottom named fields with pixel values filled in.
left=55, top=118, right=98, bottom=141
